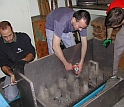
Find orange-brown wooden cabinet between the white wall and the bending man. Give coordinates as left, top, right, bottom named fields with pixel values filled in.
left=32, top=15, right=48, bottom=58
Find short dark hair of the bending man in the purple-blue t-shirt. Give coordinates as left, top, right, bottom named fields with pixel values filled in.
left=73, top=10, right=91, bottom=25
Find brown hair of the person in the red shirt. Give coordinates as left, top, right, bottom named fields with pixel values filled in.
left=105, top=7, right=124, bottom=27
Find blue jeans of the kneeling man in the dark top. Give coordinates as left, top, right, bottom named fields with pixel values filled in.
left=4, top=76, right=19, bottom=101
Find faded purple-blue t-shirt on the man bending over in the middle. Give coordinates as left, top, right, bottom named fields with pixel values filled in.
left=46, top=7, right=87, bottom=38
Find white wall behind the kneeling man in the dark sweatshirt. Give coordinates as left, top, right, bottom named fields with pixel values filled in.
left=0, top=0, right=35, bottom=77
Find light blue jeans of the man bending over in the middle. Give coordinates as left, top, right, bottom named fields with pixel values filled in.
left=46, top=29, right=76, bottom=54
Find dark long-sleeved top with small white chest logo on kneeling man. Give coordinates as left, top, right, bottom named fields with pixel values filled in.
left=0, top=33, right=35, bottom=67
